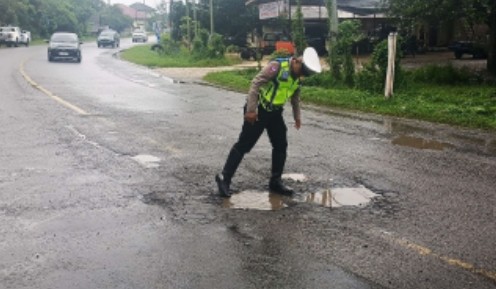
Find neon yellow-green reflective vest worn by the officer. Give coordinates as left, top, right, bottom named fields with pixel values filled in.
left=260, top=58, right=300, bottom=111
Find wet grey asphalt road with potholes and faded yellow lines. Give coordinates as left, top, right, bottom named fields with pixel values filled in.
left=0, top=39, right=496, bottom=289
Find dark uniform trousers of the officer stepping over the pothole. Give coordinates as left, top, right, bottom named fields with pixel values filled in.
left=222, top=105, right=288, bottom=184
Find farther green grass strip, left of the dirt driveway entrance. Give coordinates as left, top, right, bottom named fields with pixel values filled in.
left=121, top=44, right=241, bottom=67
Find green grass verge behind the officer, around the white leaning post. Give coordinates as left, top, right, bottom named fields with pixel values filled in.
left=205, top=70, right=496, bottom=130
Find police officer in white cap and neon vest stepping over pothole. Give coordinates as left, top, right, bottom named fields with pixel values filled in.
left=215, top=47, right=322, bottom=197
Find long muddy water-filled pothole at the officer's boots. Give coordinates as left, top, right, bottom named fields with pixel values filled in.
left=222, top=187, right=379, bottom=211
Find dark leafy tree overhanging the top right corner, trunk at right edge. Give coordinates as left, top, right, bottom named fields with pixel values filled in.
left=388, top=0, right=496, bottom=74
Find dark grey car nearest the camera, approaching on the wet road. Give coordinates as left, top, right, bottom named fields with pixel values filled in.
left=48, top=32, right=83, bottom=62
